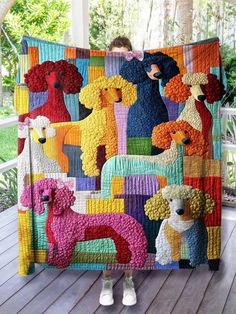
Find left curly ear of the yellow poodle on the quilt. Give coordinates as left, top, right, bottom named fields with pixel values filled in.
left=79, top=82, right=102, bottom=110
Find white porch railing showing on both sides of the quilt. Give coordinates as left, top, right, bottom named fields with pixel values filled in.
left=0, top=108, right=236, bottom=173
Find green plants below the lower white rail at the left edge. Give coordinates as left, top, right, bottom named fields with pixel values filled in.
left=0, top=157, right=17, bottom=211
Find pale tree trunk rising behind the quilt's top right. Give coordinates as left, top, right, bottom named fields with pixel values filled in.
left=175, top=0, right=193, bottom=44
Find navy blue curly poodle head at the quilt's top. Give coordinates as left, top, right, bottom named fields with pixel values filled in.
left=120, top=52, right=179, bottom=86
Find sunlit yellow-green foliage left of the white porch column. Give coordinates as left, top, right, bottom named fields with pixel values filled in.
left=1, top=0, right=70, bottom=83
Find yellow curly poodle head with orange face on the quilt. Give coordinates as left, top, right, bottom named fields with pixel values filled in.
left=80, top=75, right=137, bottom=110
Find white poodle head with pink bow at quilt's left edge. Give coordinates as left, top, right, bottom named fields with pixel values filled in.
left=18, top=116, right=56, bottom=144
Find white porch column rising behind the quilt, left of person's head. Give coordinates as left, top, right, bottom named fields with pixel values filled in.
left=71, top=0, right=89, bottom=48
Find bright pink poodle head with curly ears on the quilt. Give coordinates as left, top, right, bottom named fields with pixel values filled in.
left=20, top=178, right=75, bottom=215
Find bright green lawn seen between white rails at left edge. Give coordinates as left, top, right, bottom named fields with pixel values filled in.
left=0, top=125, right=17, bottom=163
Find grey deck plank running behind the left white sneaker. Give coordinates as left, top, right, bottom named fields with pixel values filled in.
left=70, top=272, right=122, bottom=314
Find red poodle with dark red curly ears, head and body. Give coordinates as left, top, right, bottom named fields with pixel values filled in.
left=20, top=60, right=83, bottom=123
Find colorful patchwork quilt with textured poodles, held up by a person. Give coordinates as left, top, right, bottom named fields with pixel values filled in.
left=15, top=37, right=226, bottom=275
